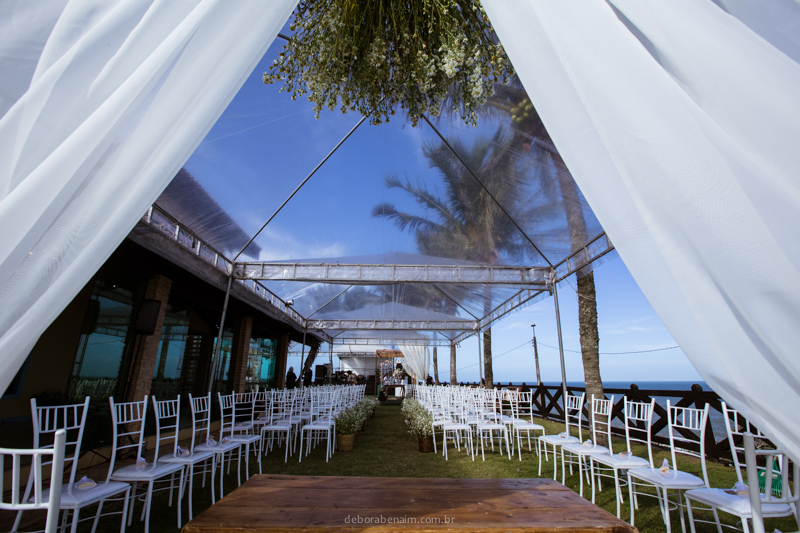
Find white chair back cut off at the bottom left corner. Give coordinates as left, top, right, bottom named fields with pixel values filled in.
left=0, top=429, right=67, bottom=533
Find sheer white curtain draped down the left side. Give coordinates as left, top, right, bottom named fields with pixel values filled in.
left=0, top=0, right=297, bottom=390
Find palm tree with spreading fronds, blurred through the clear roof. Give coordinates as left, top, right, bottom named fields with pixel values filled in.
left=372, top=127, right=557, bottom=387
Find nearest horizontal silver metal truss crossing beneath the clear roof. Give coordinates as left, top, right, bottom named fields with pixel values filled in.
left=233, top=262, right=552, bottom=287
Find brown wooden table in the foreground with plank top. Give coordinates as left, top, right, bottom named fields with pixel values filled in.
left=183, top=474, right=637, bottom=533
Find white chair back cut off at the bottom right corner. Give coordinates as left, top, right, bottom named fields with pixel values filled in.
left=742, top=431, right=800, bottom=533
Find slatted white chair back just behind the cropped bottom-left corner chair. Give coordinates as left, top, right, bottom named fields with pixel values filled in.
left=25, top=396, right=89, bottom=497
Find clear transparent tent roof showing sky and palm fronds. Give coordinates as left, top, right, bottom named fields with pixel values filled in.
left=175, top=35, right=610, bottom=343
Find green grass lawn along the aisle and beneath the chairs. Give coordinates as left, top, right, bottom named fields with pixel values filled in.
left=4, top=405, right=797, bottom=533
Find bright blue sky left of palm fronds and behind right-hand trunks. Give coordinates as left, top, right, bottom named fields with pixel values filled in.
left=186, top=42, right=699, bottom=382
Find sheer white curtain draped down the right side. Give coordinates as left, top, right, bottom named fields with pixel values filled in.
left=483, top=0, right=800, bottom=460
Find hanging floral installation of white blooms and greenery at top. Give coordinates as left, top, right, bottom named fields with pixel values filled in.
left=264, top=0, right=513, bottom=125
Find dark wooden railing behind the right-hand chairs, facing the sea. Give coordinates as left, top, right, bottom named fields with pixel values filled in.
left=531, top=385, right=731, bottom=460
